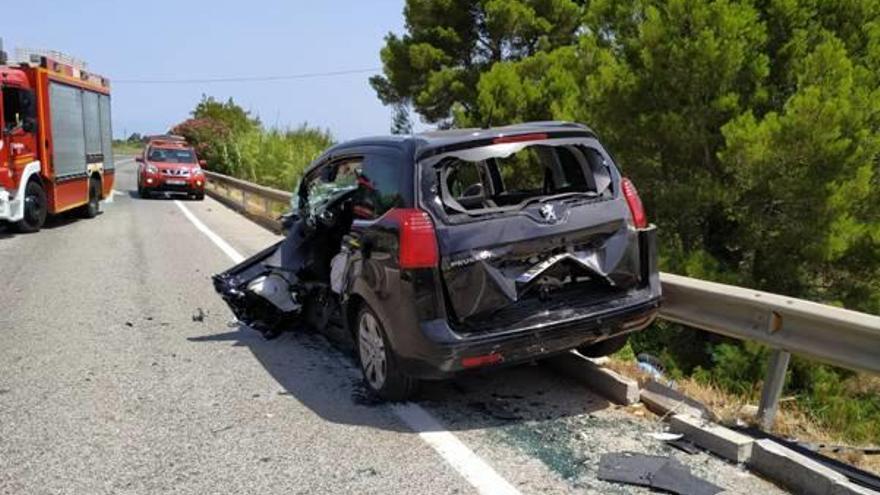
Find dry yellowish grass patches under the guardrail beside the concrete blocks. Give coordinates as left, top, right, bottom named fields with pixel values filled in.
left=604, top=359, right=880, bottom=474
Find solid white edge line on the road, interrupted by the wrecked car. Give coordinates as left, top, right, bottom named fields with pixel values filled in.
left=174, top=200, right=520, bottom=495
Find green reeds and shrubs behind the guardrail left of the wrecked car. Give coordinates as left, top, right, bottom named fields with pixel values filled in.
left=171, top=96, right=333, bottom=191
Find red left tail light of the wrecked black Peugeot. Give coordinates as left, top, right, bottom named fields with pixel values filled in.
left=388, top=208, right=439, bottom=269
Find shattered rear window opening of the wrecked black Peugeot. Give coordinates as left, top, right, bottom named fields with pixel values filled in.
left=436, top=144, right=611, bottom=214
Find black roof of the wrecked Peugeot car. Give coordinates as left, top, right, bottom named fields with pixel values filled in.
left=306, top=121, right=596, bottom=172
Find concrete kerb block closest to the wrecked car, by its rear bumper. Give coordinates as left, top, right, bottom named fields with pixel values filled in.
left=546, top=352, right=639, bottom=405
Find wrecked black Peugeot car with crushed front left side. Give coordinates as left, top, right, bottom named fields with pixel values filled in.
left=214, top=122, right=660, bottom=400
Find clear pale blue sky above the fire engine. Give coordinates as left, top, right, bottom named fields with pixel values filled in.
left=0, top=0, right=416, bottom=139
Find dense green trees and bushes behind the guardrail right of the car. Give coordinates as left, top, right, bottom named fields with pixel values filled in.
left=370, top=0, right=880, bottom=444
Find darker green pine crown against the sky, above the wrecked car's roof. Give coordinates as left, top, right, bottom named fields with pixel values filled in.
left=370, top=0, right=582, bottom=123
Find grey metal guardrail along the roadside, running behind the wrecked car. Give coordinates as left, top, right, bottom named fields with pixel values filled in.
left=206, top=172, right=880, bottom=429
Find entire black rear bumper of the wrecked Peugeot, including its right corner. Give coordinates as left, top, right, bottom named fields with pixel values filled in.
left=384, top=227, right=662, bottom=379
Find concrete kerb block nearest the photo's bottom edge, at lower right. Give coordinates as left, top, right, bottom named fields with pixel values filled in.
left=748, top=439, right=848, bottom=495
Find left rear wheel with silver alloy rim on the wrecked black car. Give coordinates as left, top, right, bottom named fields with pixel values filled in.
left=357, top=305, right=418, bottom=401
